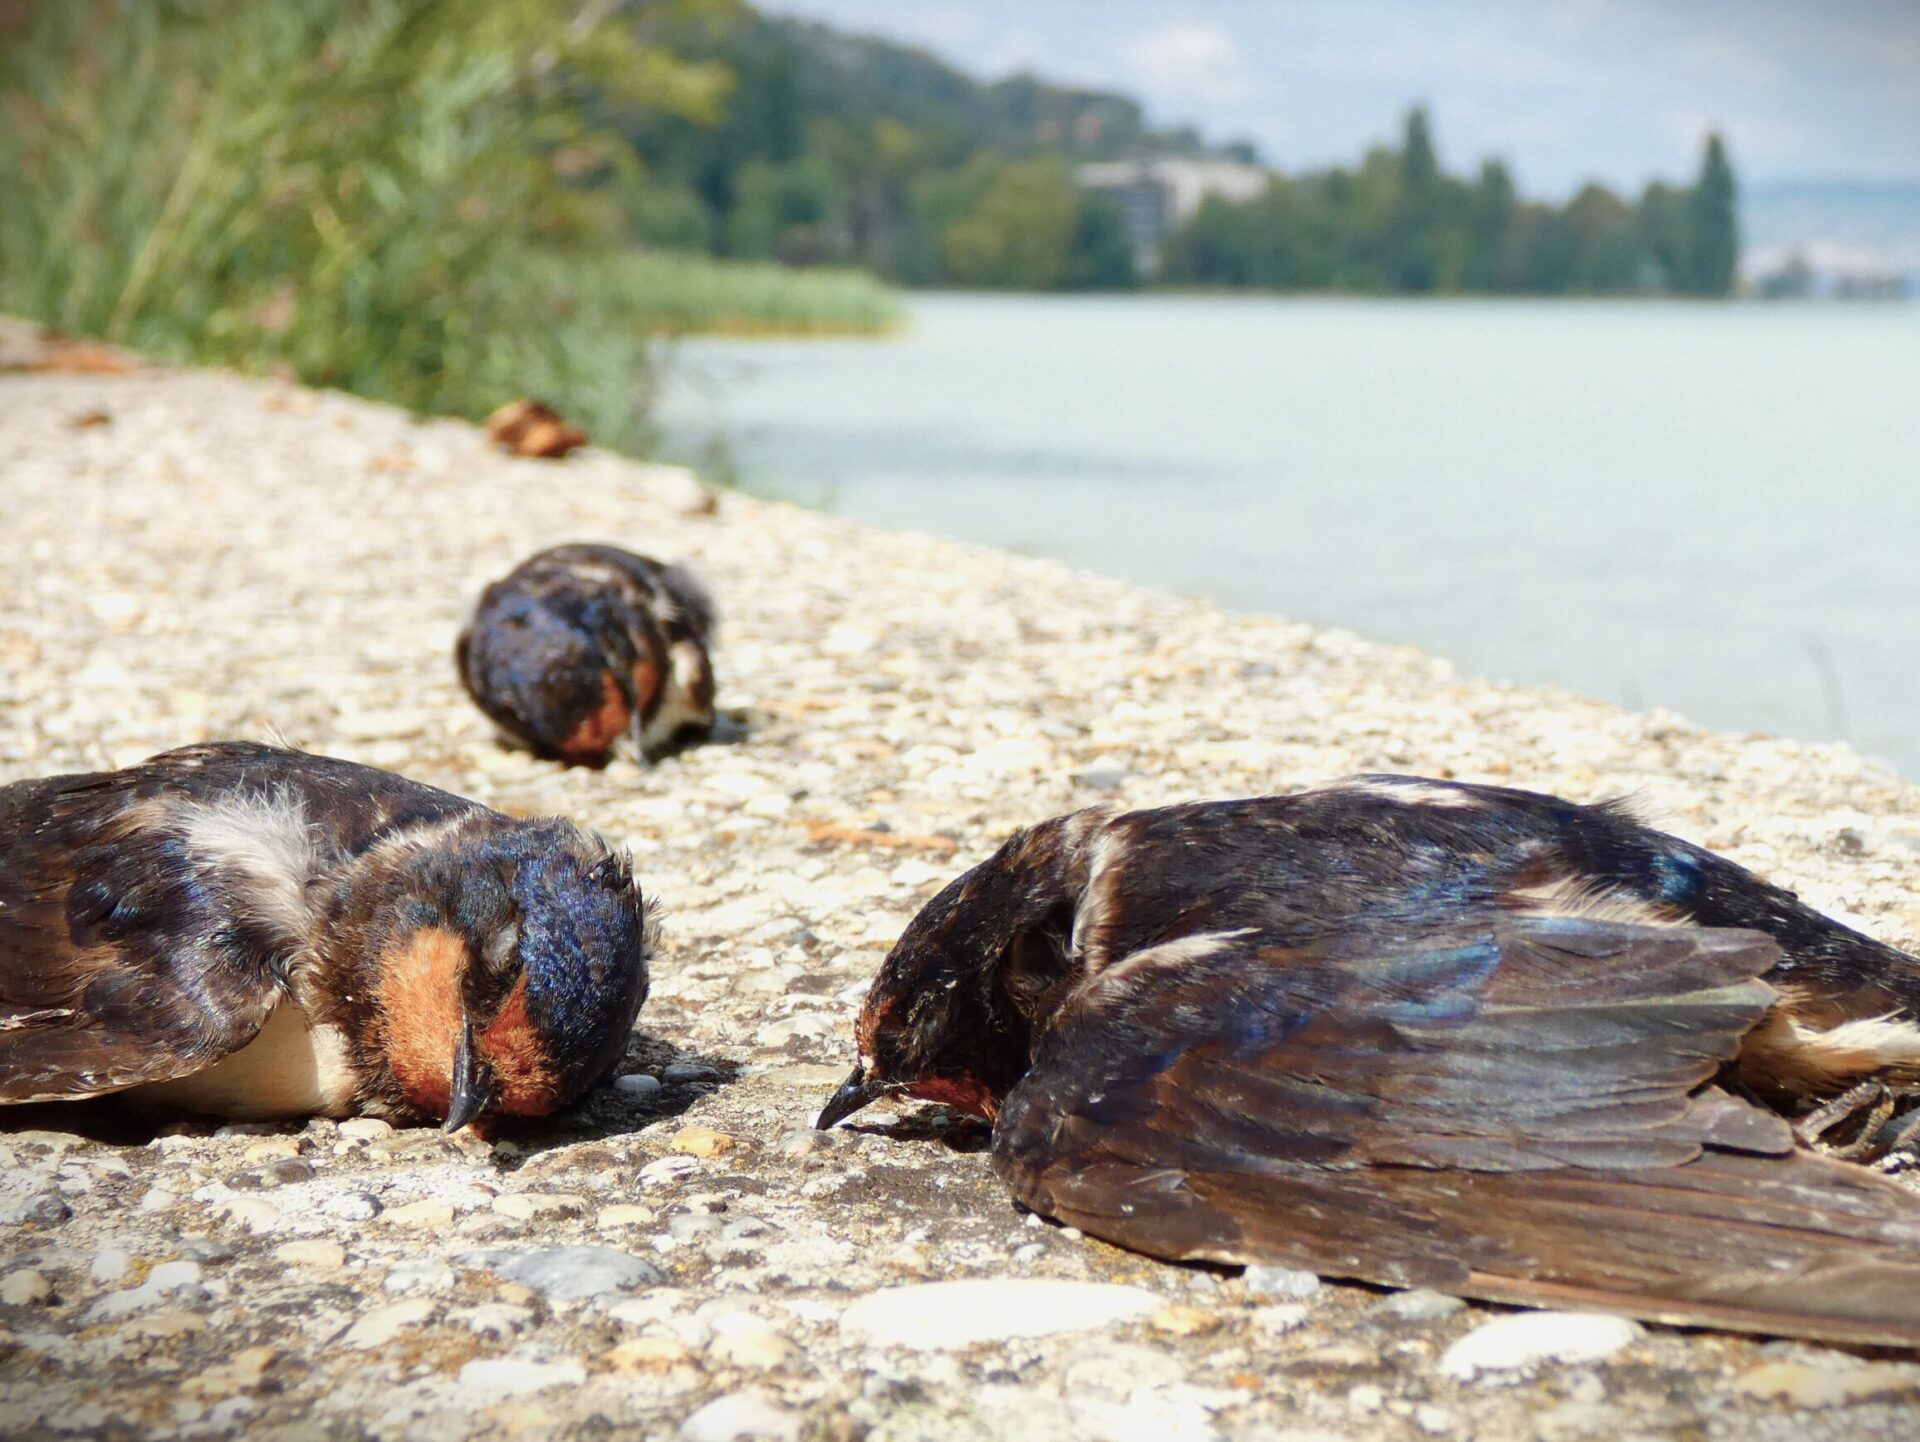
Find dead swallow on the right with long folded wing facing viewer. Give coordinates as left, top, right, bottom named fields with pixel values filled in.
left=820, top=776, right=1920, bottom=1346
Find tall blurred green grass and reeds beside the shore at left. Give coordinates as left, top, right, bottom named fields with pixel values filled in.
left=0, top=0, right=898, bottom=445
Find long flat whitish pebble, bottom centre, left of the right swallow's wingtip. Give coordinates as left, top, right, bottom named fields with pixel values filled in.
left=841, top=1277, right=1162, bottom=1352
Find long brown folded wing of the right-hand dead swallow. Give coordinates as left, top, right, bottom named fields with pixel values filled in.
left=995, top=918, right=1920, bottom=1346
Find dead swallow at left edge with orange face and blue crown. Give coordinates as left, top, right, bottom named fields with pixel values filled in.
left=0, top=741, right=649, bottom=1131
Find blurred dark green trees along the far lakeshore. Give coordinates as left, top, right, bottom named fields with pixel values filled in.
left=626, top=10, right=1740, bottom=296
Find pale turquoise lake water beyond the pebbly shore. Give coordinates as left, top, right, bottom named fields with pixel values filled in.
left=660, top=296, right=1920, bottom=778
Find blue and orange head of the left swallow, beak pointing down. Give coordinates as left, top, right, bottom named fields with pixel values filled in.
left=366, top=814, right=649, bottom=1129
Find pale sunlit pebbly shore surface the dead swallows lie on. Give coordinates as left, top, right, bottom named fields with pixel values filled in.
left=0, top=343, right=1920, bottom=1442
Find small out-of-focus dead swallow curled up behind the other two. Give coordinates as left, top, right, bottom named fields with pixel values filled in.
left=455, top=545, right=714, bottom=766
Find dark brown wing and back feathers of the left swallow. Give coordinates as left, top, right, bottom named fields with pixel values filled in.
left=0, top=743, right=472, bottom=1102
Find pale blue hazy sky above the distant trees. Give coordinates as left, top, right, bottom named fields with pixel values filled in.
left=756, top=0, right=1920, bottom=196
